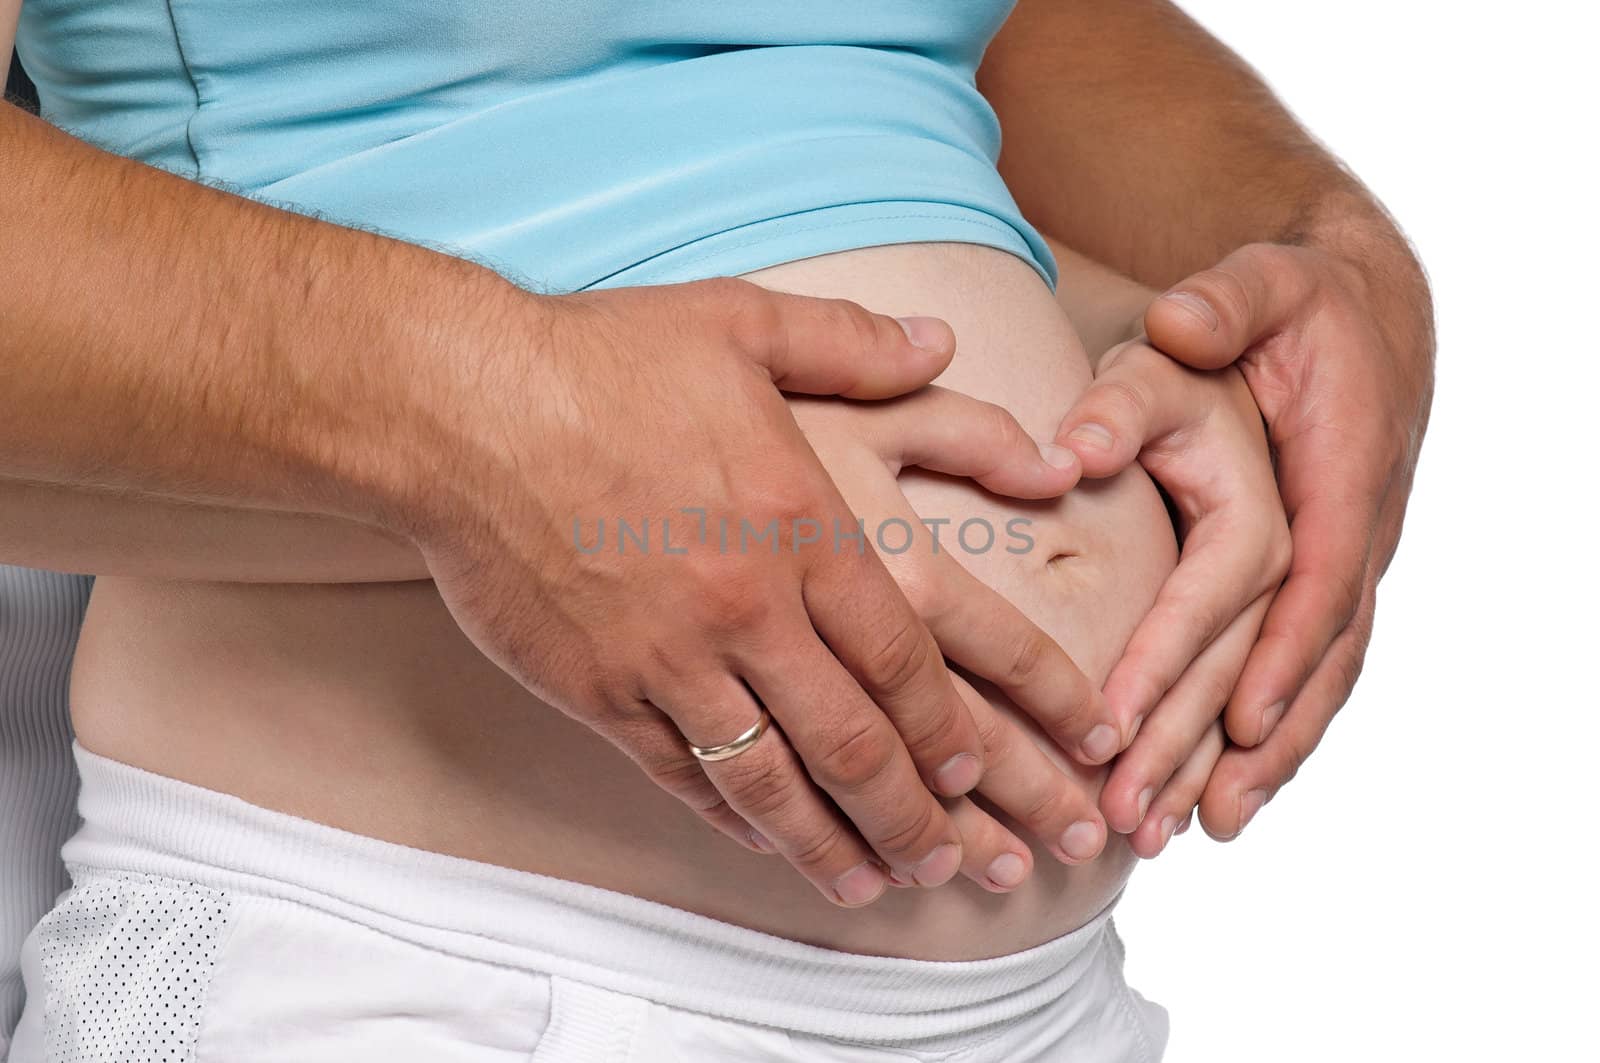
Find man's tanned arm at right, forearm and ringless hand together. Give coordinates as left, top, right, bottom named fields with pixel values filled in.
left=978, top=0, right=1434, bottom=837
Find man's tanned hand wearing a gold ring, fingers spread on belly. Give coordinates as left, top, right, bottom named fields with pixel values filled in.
left=397, top=279, right=1078, bottom=905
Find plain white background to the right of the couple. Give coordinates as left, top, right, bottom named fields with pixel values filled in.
left=1118, top=0, right=1600, bottom=1063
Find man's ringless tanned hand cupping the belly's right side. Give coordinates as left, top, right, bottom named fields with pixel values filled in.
left=1078, top=238, right=1434, bottom=839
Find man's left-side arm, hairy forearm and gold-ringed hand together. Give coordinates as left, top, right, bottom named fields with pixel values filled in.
left=0, top=106, right=1100, bottom=903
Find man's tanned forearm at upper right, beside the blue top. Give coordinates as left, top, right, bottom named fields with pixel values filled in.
left=978, top=0, right=1410, bottom=288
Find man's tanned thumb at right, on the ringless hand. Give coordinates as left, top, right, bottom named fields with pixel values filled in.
left=1144, top=243, right=1315, bottom=370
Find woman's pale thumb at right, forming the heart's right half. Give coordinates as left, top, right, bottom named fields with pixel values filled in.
left=1056, top=341, right=1205, bottom=477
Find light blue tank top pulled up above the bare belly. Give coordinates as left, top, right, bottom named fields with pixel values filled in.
left=18, top=0, right=1056, bottom=293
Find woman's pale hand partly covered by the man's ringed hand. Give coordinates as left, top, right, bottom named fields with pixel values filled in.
left=789, top=387, right=1106, bottom=892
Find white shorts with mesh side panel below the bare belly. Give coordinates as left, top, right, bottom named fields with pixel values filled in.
left=10, top=748, right=1166, bottom=1063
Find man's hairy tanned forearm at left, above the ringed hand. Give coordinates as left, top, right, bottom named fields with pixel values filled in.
left=0, top=106, right=520, bottom=541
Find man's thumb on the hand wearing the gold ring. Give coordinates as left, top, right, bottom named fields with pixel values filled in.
left=731, top=282, right=955, bottom=399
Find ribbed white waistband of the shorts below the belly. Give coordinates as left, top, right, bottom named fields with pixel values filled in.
left=62, top=744, right=1112, bottom=1045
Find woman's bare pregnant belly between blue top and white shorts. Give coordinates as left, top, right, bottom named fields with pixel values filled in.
left=72, top=243, right=1176, bottom=959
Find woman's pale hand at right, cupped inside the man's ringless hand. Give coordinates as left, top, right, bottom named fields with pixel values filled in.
left=1061, top=339, right=1290, bottom=856
